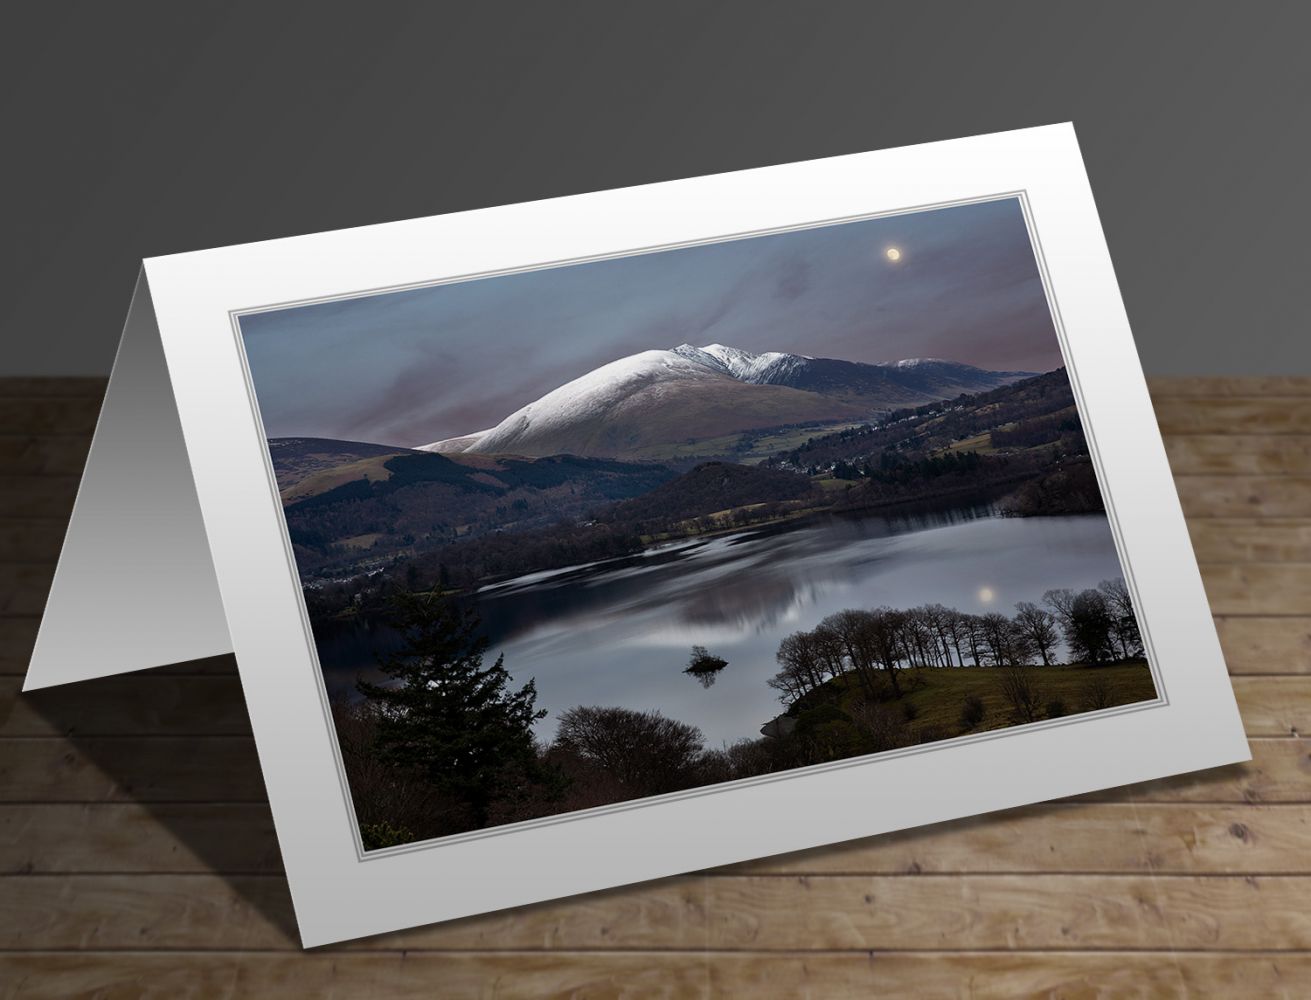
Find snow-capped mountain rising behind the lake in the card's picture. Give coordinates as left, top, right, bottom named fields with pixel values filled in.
left=423, top=343, right=1029, bottom=459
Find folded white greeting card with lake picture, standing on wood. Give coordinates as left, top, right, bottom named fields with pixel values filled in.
left=26, top=126, right=1248, bottom=945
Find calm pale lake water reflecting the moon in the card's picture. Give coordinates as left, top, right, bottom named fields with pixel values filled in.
left=317, top=507, right=1122, bottom=744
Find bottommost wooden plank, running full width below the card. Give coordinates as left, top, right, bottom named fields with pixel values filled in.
left=0, top=950, right=1311, bottom=1000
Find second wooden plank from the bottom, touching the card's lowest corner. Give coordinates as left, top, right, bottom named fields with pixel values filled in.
left=0, top=875, right=1311, bottom=952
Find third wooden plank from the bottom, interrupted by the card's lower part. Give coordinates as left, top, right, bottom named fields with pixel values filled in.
left=10, top=802, right=1311, bottom=875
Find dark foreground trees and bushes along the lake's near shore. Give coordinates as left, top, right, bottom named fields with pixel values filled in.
left=333, top=579, right=1142, bottom=849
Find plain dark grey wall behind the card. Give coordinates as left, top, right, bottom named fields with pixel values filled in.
left=0, top=0, right=1311, bottom=375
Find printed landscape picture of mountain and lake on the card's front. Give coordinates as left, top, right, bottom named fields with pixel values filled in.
left=239, top=197, right=1158, bottom=851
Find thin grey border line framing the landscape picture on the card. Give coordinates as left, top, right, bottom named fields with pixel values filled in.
left=228, top=189, right=1169, bottom=862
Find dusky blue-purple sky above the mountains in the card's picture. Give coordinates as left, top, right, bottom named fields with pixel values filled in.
left=241, top=199, right=1062, bottom=446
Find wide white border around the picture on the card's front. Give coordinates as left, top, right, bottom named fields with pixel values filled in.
left=138, top=125, right=1248, bottom=946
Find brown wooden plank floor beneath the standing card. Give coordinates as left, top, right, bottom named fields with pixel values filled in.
left=0, top=379, right=1311, bottom=997
